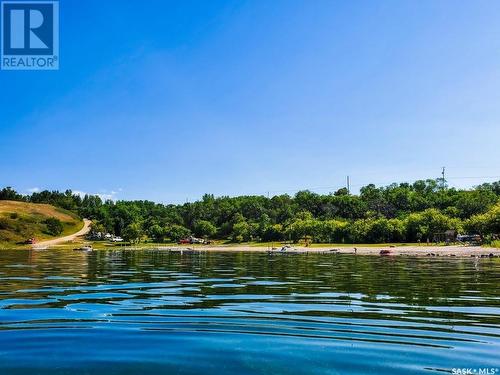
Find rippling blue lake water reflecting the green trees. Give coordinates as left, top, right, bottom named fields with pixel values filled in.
left=0, top=250, right=500, bottom=375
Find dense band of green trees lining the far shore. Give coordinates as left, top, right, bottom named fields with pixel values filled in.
left=0, top=180, right=500, bottom=243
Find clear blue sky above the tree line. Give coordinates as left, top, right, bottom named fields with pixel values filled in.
left=0, top=0, right=500, bottom=202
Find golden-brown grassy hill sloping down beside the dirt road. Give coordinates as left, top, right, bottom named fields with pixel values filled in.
left=0, top=201, right=83, bottom=248
